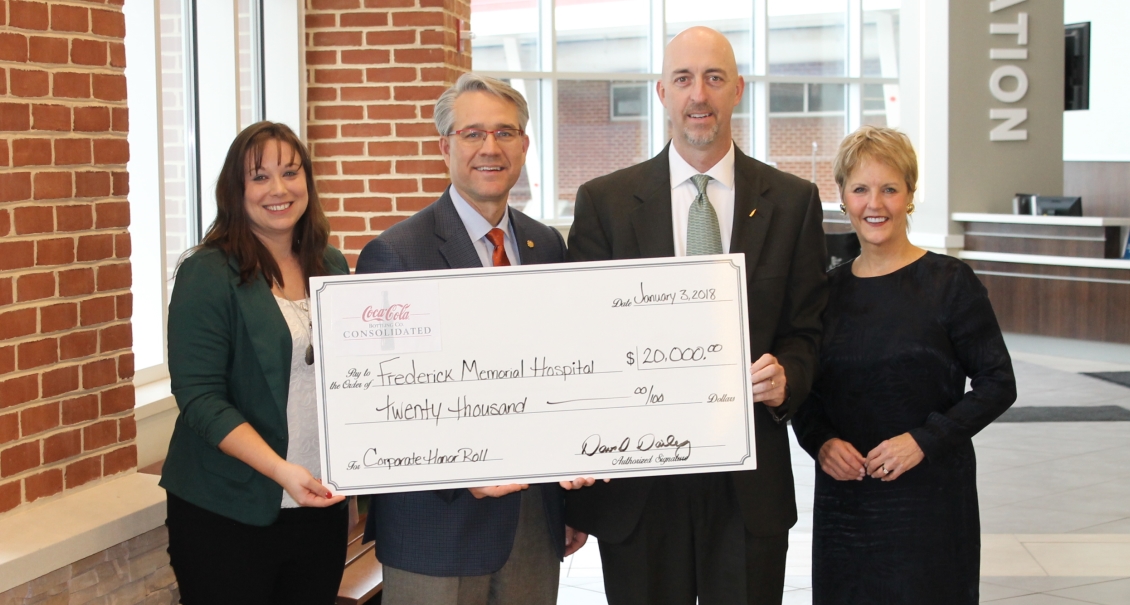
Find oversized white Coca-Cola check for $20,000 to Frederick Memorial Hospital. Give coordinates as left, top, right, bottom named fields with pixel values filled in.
left=311, top=254, right=756, bottom=494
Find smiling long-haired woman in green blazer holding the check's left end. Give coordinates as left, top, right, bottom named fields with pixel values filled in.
left=160, top=122, right=349, bottom=605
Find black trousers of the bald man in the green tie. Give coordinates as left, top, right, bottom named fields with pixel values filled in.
left=599, top=474, right=789, bottom=605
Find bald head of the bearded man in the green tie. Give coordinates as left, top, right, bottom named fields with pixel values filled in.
left=655, top=27, right=746, bottom=172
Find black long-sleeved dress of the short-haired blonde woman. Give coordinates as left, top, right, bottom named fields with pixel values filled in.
left=793, top=252, right=1016, bottom=605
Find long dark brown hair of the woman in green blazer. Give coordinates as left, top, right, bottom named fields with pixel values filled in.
left=197, top=121, right=330, bottom=287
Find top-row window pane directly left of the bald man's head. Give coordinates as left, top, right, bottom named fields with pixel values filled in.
left=554, top=0, right=651, bottom=74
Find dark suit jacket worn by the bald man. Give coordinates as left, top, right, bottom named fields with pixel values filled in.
left=565, top=145, right=828, bottom=543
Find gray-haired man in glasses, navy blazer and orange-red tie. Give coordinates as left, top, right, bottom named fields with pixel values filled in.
left=357, top=74, right=592, bottom=605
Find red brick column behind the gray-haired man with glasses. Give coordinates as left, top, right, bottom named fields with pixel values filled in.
left=306, top=0, right=471, bottom=268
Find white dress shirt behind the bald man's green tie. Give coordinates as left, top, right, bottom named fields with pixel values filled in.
left=667, top=141, right=733, bottom=257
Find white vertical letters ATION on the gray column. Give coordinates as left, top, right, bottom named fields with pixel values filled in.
left=989, top=0, right=1028, bottom=141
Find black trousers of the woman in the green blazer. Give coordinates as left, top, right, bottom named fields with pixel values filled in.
left=165, top=494, right=349, bottom=605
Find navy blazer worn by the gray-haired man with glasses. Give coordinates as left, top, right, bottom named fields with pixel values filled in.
left=357, top=192, right=565, bottom=577
